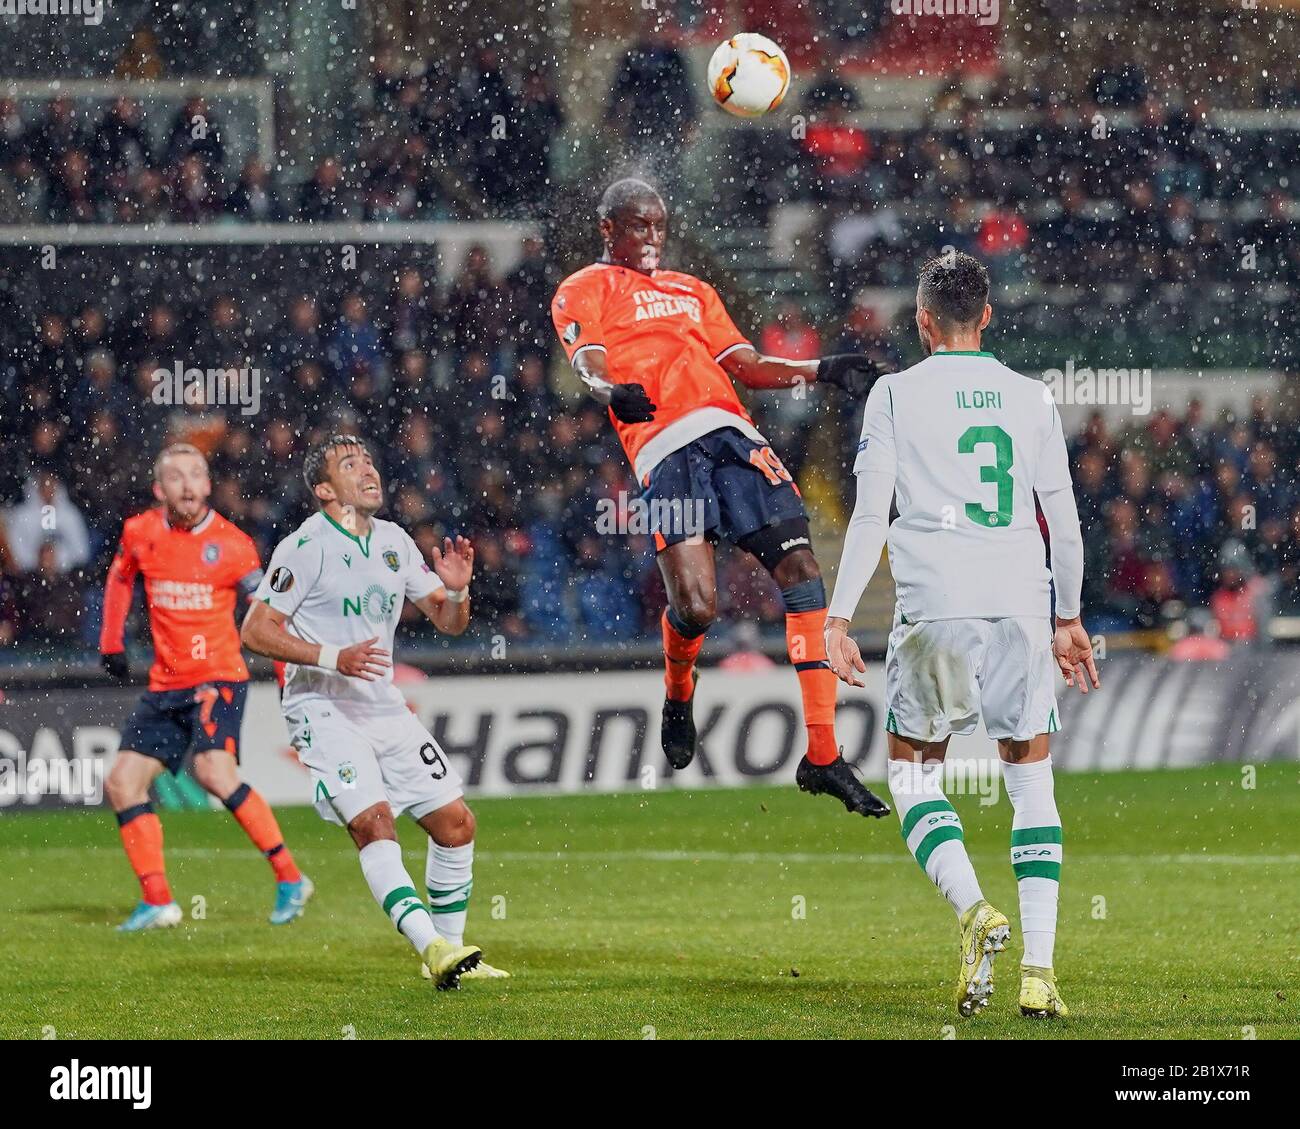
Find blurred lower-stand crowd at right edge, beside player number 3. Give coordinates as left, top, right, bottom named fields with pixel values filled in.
left=1070, top=397, right=1300, bottom=643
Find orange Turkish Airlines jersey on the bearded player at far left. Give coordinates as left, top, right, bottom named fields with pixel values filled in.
left=99, top=509, right=261, bottom=691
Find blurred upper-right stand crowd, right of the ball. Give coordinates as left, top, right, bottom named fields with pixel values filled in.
left=764, top=79, right=1300, bottom=300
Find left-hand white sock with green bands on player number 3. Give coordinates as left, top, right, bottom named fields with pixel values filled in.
left=889, top=760, right=984, bottom=917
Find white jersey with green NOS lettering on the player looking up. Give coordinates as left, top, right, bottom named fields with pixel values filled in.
left=256, top=511, right=443, bottom=713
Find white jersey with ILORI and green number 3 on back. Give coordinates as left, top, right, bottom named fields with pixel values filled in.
left=850, top=352, right=1070, bottom=623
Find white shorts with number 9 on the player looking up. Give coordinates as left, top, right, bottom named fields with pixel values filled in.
left=285, top=701, right=464, bottom=826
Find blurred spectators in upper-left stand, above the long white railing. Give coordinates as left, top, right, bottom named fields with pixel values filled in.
left=0, top=49, right=564, bottom=224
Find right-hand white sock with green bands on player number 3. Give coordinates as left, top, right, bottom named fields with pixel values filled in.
left=1002, top=757, right=1062, bottom=968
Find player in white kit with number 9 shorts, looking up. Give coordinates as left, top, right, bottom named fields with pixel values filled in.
left=242, top=434, right=508, bottom=989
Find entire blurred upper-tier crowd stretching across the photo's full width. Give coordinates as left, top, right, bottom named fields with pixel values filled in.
left=0, top=59, right=1300, bottom=368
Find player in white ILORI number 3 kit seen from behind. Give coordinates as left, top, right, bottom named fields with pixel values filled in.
left=827, top=255, right=1100, bottom=1017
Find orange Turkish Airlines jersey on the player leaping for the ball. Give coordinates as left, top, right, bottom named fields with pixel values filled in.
left=551, top=263, right=763, bottom=484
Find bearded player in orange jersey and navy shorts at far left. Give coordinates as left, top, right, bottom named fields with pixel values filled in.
left=99, top=444, right=312, bottom=933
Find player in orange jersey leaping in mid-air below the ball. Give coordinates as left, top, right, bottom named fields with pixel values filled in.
left=551, top=179, right=889, bottom=816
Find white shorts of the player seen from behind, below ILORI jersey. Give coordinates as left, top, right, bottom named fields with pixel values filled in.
left=885, top=618, right=1061, bottom=741
